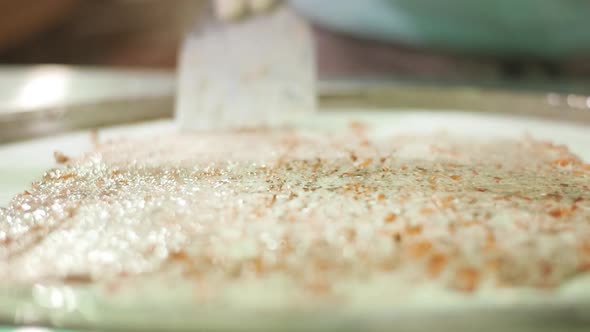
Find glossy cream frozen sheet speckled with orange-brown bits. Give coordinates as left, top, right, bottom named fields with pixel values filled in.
left=0, top=113, right=588, bottom=330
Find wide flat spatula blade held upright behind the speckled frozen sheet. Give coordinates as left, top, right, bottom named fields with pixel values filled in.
left=176, top=6, right=316, bottom=130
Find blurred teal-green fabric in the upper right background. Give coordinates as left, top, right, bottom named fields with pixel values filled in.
left=291, top=0, right=590, bottom=59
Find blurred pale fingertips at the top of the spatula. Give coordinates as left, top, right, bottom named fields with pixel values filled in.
left=214, top=0, right=280, bottom=21
